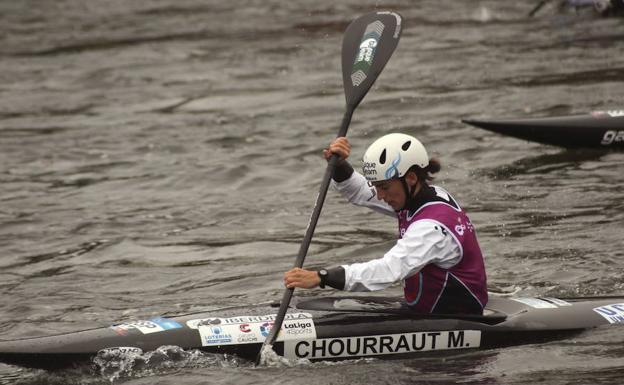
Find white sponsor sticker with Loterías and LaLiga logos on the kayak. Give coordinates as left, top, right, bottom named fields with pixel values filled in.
left=186, top=313, right=316, bottom=346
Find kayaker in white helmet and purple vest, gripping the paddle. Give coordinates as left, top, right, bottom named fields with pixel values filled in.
left=284, top=133, right=488, bottom=314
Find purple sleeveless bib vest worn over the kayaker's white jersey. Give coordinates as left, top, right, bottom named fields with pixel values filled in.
left=398, top=196, right=488, bottom=314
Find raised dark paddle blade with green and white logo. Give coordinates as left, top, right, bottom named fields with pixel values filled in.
left=342, top=11, right=402, bottom=110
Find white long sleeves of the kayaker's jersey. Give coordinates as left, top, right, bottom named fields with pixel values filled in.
left=332, top=171, right=462, bottom=291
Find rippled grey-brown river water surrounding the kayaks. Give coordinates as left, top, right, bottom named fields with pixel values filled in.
left=0, top=0, right=624, bottom=385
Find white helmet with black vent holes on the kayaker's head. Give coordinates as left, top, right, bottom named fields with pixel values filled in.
left=362, top=133, right=429, bottom=182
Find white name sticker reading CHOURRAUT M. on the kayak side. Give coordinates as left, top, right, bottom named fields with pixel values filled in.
left=284, top=330, right=481, bottom=359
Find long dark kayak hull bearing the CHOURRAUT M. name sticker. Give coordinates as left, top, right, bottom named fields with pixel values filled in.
left=0, top=297, right=624, bottom=370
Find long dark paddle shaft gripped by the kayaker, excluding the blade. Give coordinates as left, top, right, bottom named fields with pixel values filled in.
left=264, top=106, right=355, bottom=345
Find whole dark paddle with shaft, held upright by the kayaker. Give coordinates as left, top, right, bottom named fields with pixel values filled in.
left=256, top=12, right=401, bottom=363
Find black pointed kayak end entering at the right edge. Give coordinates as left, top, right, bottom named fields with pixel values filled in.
left=462, top=111, right=624, bottom=150
